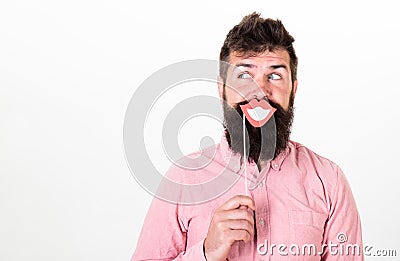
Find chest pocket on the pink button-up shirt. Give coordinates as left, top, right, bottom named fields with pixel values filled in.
left=289, top=210, right=327, bottom=260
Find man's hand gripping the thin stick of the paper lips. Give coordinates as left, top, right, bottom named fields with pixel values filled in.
left=204, top=195, right=255, bottom=261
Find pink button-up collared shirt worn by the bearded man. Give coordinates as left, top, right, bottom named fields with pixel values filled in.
left=131, top=138, right=364, bottom=260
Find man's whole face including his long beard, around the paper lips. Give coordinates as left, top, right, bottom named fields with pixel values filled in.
left=218, top=50, right=297, bottom=162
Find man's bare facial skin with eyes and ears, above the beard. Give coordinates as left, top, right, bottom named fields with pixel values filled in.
left=219, top=50, right=297, bottom=110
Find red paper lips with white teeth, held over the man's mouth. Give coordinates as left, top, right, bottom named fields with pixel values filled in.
left=240, top=99, right=276, bottom=127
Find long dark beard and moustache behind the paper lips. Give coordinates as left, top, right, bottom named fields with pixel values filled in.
left=223, top=92, right=294, bottom=163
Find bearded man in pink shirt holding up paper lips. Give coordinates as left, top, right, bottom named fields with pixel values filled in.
left=132, top=13, right=364, bottom=261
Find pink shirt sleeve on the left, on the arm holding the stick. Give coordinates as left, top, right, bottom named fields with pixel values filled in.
left=131, top=164, right=206, bottom=261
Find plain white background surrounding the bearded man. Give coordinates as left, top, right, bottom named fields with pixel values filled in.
left=0, top=0, right=400, bottom=261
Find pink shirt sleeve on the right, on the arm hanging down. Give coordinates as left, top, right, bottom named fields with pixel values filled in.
left=322, top=166, right=364, bottom=261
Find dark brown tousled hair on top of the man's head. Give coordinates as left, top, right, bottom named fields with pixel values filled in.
left=219, top=12, right=297, bottom=83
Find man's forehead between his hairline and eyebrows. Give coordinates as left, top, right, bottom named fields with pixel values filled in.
left=229, top=49, right=290, bottom=69
